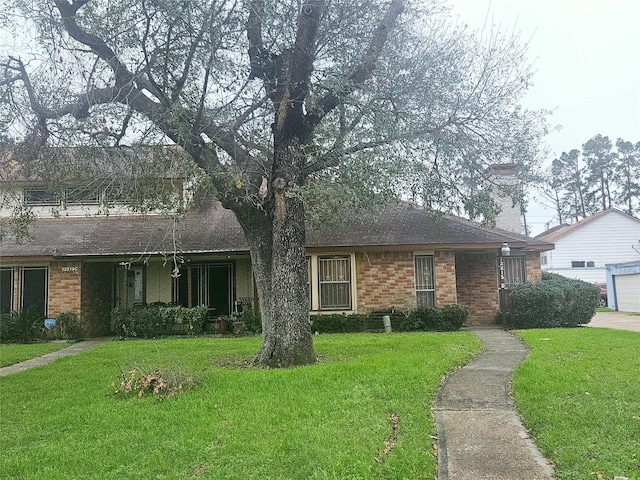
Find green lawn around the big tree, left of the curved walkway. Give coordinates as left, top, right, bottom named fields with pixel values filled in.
left=0, top=333, right=480, bottom=479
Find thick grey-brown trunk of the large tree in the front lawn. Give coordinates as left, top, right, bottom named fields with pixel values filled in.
left=236, top=140, right=316, bottom=368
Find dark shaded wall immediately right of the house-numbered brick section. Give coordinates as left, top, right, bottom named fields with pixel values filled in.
left=81, top=263, right=114, bottom=337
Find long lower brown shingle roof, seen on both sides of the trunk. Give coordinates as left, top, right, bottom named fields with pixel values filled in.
left=0, top=203, right=553, bottom=258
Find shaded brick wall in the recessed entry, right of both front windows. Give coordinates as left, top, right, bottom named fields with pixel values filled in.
left=455, top=253, right=499, bottom=325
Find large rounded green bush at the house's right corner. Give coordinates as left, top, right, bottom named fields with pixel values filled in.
left=500, top=272, right=600, bottom=328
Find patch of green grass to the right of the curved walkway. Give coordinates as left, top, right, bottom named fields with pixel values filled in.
left=513, top=328, right=640, bottom=480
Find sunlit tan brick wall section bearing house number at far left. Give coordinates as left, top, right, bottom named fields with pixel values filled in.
left=48, top=261, right=82, bottom=318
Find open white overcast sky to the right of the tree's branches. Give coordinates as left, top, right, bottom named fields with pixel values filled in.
left=449, top=0, right=640, bottom=235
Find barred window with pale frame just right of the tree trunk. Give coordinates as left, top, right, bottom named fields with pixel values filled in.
left=318, top=256, right=351, bottom=310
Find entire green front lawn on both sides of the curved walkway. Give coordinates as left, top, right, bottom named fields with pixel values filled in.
left=0, top=328, right=640, bottom=480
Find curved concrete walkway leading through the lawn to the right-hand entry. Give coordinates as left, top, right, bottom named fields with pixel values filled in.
left=435, top=327, right=554, bottom=480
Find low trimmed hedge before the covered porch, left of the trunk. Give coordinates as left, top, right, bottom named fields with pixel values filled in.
left=111, top=306, right=208, bottom=338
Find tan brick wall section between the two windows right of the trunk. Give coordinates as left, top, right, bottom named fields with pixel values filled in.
left=356, top=252, right=416, bottom=313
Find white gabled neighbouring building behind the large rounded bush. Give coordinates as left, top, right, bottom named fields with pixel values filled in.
left=536, top=209, right=640, bottom=283
